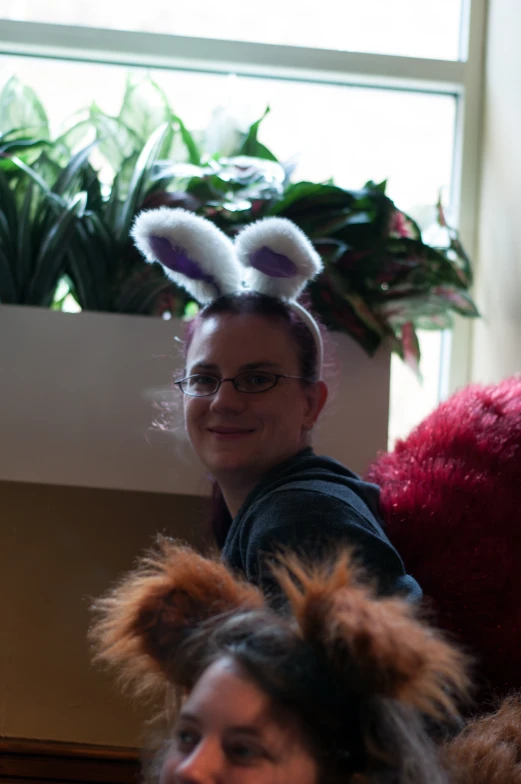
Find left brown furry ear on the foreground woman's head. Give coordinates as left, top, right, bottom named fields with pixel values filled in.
left=90, top=537, right=263, bottom=695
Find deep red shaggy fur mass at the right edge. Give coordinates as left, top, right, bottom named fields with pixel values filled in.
left=367, top=377, right=521, bottom=693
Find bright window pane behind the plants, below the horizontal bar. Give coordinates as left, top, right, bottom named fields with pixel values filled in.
left=0, top=50, right=456, bottom=443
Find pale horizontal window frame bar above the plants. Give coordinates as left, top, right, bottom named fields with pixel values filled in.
left=0, top=20, right=465, bottom=93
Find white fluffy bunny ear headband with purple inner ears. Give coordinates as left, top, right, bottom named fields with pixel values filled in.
left=131, top=207, right=324, bottom=374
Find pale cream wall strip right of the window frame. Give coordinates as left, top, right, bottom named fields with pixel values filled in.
left=471, top=0, right=521, bottom=382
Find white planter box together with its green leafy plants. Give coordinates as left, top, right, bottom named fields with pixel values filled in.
left=0, top=75, right=476, bottom=493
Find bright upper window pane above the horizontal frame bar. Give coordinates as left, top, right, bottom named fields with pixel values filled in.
left=1, top=0, right=461, bottom=60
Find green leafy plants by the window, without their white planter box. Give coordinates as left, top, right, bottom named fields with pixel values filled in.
left=0, top=73, right=477, bottom=367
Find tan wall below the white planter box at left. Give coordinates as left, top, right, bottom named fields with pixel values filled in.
left=0, top=482, right=207, bottom=746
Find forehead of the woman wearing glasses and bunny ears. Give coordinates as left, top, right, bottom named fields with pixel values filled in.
left=187, top=313, right=297, bottom=366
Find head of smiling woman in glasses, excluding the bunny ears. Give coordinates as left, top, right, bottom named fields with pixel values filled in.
left=181, top=292, right=327, bottom=544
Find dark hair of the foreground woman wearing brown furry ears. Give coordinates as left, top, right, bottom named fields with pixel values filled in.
left=173, top=610, right=447, bottom=784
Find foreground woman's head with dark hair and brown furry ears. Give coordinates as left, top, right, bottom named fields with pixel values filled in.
left=93, top=540, right=467, bottom=784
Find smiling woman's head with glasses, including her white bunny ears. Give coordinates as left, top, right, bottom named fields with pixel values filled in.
left=134, top=208, right=327, bottom=544
